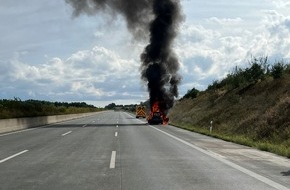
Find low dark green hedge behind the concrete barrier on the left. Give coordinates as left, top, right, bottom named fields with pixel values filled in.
left=0, top=98, right=102, bottom=119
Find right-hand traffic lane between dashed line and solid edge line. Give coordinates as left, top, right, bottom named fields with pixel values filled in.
left=116, top=120, right=280, bottom=190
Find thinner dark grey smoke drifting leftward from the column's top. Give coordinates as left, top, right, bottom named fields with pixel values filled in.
left=65, top=0, right=153, bottom=39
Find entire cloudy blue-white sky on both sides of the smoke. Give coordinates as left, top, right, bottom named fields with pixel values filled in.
left=0, top=0, right=290, bottom=107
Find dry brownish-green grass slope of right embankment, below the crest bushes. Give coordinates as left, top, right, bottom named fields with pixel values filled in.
left=169, top=75, right=290, bottom=157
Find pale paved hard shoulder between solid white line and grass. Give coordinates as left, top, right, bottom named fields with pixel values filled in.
left=150, top=121, right=290, bottom=188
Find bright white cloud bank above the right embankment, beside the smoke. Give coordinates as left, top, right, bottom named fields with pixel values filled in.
left=176, top=6, right=290, bottom=91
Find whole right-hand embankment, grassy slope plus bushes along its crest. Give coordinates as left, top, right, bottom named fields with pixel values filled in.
left=169, top=57, right=290, bottom=158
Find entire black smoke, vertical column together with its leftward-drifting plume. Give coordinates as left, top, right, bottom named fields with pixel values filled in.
left=65, top=0, right=182, bottom=114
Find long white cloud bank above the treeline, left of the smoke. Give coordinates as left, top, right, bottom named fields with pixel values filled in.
left=0, top=46, right=144, bottom=105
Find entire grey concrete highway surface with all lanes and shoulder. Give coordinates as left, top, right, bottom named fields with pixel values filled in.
left=0, top=111, right=290, bottom=190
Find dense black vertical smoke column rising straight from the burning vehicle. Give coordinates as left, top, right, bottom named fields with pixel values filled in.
left=141, top=0, right=182, bottom=114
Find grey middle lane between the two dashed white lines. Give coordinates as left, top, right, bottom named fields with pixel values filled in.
left=0, top=112, right=120, bottom=189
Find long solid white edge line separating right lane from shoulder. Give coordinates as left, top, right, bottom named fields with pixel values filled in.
left=148, top=125, right=289, bottom=190
